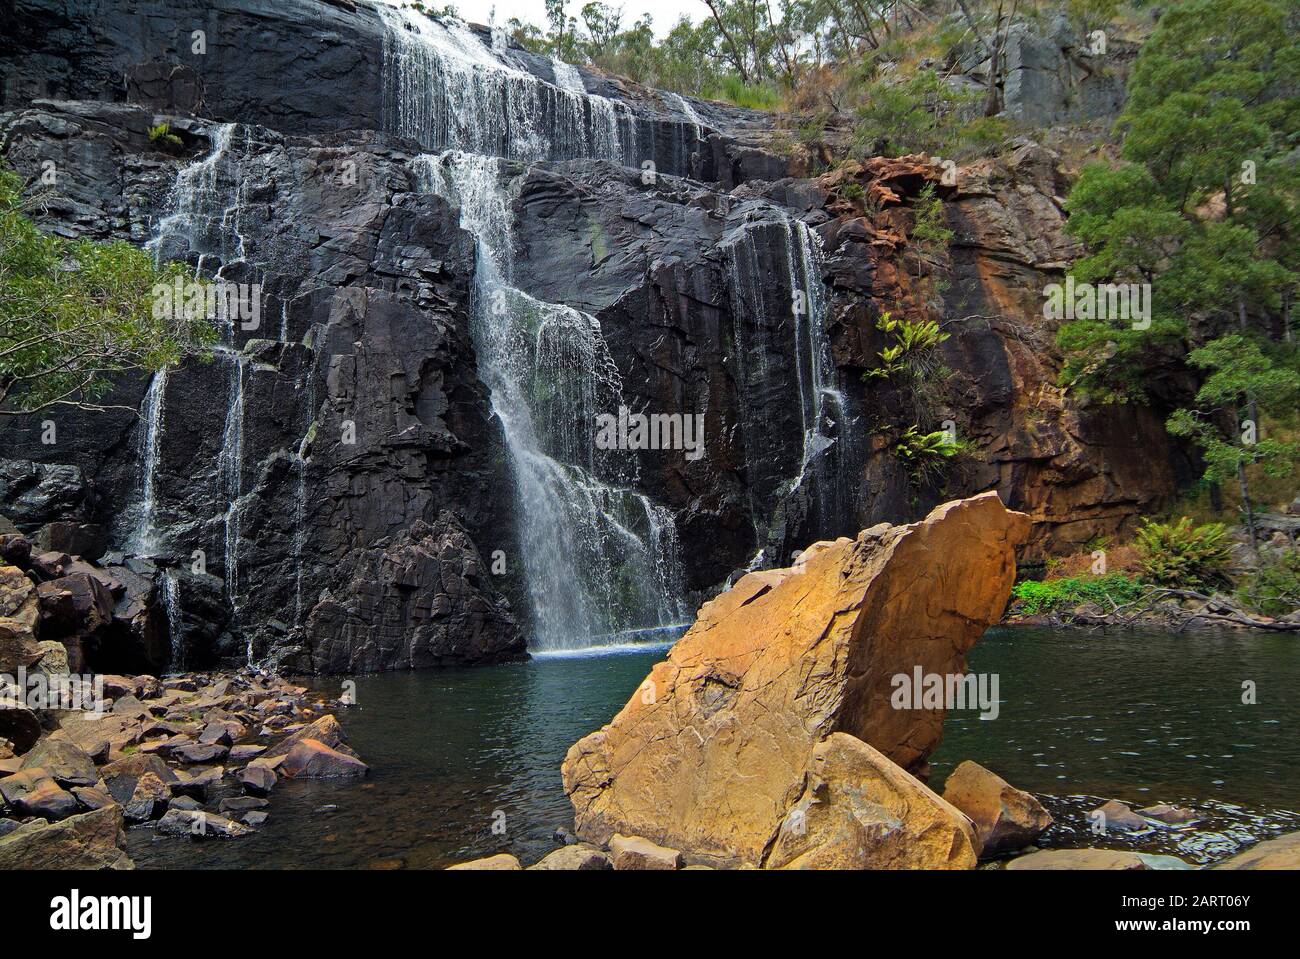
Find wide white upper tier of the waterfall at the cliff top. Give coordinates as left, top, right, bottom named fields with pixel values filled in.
left=377, top=4, right=647, bottom=162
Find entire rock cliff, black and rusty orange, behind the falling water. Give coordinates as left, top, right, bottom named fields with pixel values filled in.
left=0, top=0, right=1183, bottom=672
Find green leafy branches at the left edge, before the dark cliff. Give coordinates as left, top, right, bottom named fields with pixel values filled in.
left=0, top=169, right=215, bottom=413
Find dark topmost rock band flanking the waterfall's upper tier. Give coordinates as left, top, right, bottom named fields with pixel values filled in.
left=0, top=0, right=754, bottom=179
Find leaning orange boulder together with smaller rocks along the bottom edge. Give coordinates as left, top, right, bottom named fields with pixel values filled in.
left=452, top=494, right=1300, bottom=871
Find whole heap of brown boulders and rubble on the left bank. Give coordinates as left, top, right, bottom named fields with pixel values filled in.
left=0, top=522, right=367, bottom=869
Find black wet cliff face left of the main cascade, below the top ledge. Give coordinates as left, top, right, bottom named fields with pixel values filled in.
left=0, top=104, right=519, bottom=669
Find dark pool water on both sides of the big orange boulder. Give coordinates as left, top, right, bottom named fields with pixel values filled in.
left=127, top=628, right=1300, bottom=868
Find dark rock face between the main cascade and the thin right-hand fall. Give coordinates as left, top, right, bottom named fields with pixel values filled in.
left=515, top=161, right=852, bottom=591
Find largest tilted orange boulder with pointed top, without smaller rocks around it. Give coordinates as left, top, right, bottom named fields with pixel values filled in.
left=563, top=492, right=1030, bottom=865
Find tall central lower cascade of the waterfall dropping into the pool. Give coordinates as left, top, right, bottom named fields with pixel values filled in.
left=413, top=152, right=684, bottom=650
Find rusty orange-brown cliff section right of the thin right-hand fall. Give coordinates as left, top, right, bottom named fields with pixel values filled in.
left=818, top=142, right=1188, bottom=556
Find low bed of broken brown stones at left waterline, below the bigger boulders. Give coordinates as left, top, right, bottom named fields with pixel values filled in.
left=0, top=671, right=367, bottom=869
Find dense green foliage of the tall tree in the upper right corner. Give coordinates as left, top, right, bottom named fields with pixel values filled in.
left=1058, top=0, right=1300, bottom=402
